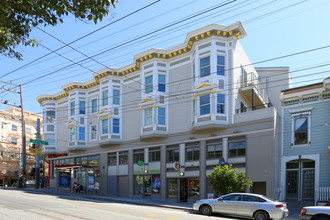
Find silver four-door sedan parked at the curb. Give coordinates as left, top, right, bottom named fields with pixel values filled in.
left=193, top=193, right=289, bottom=220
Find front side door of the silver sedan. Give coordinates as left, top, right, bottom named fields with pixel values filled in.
left=214, top=194, right=240, bottom=215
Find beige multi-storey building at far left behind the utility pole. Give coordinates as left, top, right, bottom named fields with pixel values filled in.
left=0, top=108, right=42, bottom=186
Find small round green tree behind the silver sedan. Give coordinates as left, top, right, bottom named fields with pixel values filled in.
left=207, top=164, right=252, bottom=195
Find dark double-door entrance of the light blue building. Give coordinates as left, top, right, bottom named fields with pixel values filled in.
left=286, top=160, right=315, bottom=200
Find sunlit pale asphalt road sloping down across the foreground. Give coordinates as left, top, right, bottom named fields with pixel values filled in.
left=0, top=189, right=237, bottom=220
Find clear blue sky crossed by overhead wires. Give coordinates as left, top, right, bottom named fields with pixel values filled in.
left=0, top=0, right=330, bottom=113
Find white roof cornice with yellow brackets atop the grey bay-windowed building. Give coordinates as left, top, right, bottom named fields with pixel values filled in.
left=37, top=22, right=247, bottom=104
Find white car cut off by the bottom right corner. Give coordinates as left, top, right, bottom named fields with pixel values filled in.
left=300, top=206, right=330, bottom=220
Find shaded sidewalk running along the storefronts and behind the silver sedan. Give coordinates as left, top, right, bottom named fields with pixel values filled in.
left=21, top=188, right=300, bottom=220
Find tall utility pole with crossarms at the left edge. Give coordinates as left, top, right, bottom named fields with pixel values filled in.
left=0, top=80, right=26, bottom=187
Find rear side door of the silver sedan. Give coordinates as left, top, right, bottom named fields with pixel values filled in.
left=237, top=194, right=258, bottom=216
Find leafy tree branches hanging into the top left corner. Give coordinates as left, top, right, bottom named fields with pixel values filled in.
left=0, top=0, right=117, bottom=60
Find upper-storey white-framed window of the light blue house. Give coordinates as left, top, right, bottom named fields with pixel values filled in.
left=292, top=112, right=311, bottom=145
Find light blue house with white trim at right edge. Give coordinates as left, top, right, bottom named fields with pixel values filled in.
left=281, top=77, right=330, bottom=203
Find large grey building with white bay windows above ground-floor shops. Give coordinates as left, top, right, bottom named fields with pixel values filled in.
left=38, top=22, right=291, bottom=202
